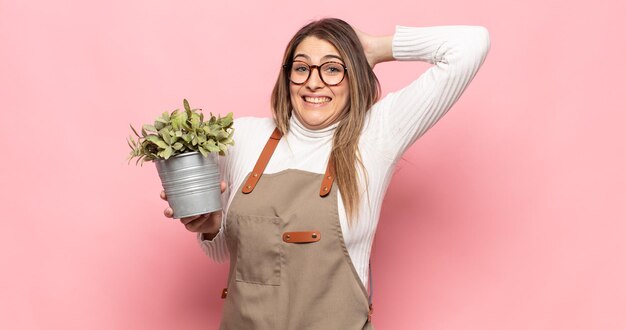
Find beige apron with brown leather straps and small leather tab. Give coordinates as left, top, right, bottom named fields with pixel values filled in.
left=220, top=130, right=373, bottom=330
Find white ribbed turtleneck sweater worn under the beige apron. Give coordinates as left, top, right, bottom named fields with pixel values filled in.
left=198, top=26, right=490, bottom=285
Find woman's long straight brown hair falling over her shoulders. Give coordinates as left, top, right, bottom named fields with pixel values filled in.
left=271, top=18, right=380, bottom=224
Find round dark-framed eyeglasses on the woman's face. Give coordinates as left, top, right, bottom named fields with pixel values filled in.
left=283, top=61, right=348, bottom=86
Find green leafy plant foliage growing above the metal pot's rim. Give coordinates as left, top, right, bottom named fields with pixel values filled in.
left=128, top=99, right=235, bottom=165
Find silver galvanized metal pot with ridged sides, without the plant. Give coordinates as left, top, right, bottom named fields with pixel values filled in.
left=154, top=152, right=222, bottom=219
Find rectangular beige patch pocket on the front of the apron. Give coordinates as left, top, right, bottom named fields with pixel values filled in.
left=235, top=215, right=282, bottom=285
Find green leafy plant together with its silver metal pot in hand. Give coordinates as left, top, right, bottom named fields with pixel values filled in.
left=128, top=100, right=234, bottom=219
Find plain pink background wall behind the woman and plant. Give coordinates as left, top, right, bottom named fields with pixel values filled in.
left=0, top=0, right=626, bottom=330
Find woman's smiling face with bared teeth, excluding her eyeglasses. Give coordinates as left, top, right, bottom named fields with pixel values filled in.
left=289, top=37, right=350, bottom=130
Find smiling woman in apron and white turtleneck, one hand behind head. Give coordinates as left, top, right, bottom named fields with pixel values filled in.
left=162, top=19, right=490, bottom=329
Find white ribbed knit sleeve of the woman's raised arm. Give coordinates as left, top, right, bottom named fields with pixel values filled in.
left=369, top=25, right=490, bottom=160
